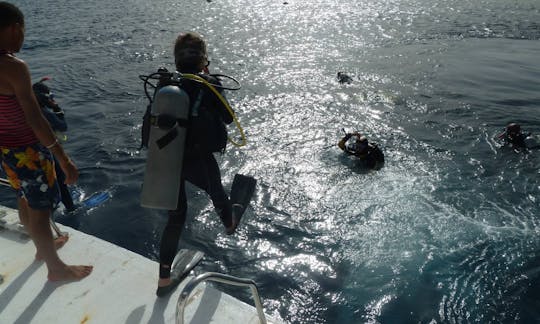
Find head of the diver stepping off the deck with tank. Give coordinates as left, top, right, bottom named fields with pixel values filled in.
left=174, top=32, right=209, bottom=73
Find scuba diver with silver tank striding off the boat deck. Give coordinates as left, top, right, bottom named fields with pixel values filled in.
left=141, top=32, right=252, bottom=297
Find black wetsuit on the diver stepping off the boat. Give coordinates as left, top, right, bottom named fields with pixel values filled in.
left=159, top=72, right=233, bottom=278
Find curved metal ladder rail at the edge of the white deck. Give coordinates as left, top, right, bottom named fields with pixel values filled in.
left=176, top=272, right=266, bottom=324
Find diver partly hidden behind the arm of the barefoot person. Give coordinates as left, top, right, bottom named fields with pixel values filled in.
left=32, top=77, right=75, bottom=211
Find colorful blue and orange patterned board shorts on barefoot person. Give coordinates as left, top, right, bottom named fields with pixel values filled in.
left=0, top=143, right=60, bottom=210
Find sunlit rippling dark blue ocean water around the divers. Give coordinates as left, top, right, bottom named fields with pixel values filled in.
left=4, top=0, right=540, bottom=323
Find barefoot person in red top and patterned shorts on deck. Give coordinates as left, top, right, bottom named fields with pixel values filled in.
left=0, top=1, right=93, bottom=281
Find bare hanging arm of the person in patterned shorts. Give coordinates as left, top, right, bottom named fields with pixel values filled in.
left=6, top=59, right=79, bottom=184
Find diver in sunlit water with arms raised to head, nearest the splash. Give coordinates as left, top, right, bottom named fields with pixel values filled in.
left=338, top=132, right=384, bottom=170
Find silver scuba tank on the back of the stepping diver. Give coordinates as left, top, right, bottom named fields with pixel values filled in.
left=141, top=85, right=190, bottom=210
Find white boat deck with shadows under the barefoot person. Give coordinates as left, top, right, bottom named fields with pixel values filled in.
left=0, top=206, right=276, bottom=324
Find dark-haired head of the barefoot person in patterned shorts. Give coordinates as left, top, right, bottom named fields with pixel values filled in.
left=0, top=1, right=25, bottom=52
